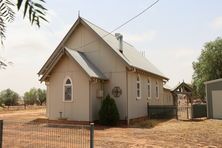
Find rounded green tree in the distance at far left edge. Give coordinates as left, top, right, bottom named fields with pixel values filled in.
left=0, top=89, right=20, bottom=106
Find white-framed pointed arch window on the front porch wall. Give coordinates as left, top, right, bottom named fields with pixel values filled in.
left=63, top=77, right=73, bottom=102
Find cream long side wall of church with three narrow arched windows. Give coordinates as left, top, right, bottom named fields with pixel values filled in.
left=128, top=72, right=165, bottom=119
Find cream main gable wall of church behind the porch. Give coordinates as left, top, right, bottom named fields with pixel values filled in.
left=66, top=24, right=127, bottom=120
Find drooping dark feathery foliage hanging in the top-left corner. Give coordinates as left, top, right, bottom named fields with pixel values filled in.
left=0, top=0, right=47, bottom=69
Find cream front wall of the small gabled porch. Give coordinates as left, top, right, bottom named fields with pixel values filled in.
left=47, top=55, right=89, bottom=121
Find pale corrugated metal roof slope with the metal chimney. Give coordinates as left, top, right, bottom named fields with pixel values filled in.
left=81, top=18, right=168, bottom=79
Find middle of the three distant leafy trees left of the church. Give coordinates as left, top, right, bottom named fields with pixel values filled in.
left=23, top=88, right=38, bottom=105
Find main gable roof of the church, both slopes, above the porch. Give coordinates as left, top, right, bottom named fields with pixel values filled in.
left=38, top=17, right=168, bottom=80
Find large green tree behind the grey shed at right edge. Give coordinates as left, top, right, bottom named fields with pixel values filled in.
left=193, top=38, right=222, bottom=99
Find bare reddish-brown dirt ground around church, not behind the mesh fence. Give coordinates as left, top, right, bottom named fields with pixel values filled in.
left=0, top=109, right=222, bottom=148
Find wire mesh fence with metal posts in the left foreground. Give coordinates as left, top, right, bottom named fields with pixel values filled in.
left=0, top=120, right=94, bottom=148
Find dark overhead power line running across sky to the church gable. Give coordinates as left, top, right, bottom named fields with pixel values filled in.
left=76, top=0, right=159, bottom=49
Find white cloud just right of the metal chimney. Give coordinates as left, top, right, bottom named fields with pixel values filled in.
left=123, top=30, right=157, bottom=43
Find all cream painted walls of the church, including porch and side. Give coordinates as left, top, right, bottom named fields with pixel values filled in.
left=47, top=24, right=168, bottom=121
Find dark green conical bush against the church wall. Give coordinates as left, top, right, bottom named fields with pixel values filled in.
left=99, top=95, right=119, bottom=125
